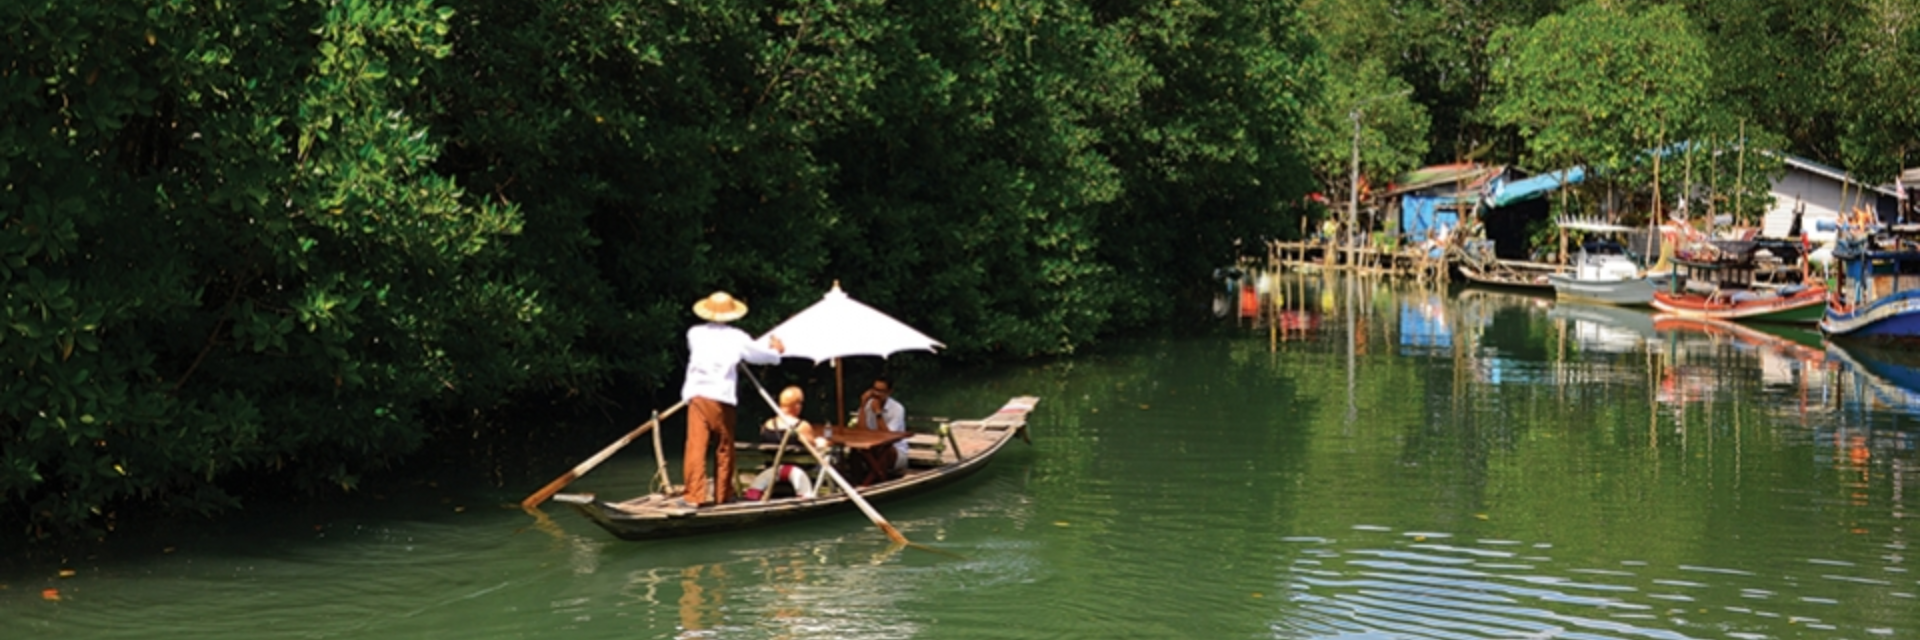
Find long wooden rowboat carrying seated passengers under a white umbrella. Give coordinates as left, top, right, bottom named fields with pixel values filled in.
left=553, top=396, right=1041, bottom=540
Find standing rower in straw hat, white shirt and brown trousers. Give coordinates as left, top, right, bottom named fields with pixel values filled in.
left=680, top=290, right=787, bottom=505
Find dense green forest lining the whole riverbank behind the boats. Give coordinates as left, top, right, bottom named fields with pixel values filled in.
left=0, top=0, right=1920, bottom=534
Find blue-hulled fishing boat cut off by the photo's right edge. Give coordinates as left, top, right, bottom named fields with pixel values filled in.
left=1820, top=229, right=1920, bottom=340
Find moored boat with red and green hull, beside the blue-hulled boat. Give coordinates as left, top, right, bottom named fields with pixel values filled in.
left=1653, top=259, right=1826, bottom=325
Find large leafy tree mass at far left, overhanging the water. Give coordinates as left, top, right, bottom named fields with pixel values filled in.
left=0, top=2, right=543, bottom=529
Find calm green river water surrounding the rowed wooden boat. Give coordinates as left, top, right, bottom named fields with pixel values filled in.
left=0, top=275, right=1920, bottom=638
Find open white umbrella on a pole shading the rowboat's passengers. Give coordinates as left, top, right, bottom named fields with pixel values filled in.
left=760, top=281, right=947, bottom=421
